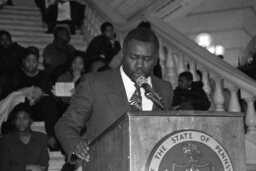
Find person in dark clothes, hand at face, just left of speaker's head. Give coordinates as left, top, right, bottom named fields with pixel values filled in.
left=85, top=22, right=121, bottom=68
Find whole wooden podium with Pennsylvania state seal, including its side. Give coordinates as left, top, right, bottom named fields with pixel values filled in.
left=83, top=111, right=246, bottom=171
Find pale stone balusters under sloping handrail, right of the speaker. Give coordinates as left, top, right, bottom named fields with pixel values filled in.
left=159, top=43, right=256, bottom=134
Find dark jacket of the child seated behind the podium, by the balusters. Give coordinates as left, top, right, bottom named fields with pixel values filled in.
left=173, top=81, right=211, bottom=110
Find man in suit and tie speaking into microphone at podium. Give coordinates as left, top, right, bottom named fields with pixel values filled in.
left=55, top=28, right=173, bottom=161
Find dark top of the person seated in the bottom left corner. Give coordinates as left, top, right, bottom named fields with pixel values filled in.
left=0, top=131, right=49, bottom=171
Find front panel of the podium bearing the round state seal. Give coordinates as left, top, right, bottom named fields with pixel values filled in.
left=129, top=115, right=246, bottom=171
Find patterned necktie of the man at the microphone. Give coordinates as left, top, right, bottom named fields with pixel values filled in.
left=129, top=84, right=142, bottom=111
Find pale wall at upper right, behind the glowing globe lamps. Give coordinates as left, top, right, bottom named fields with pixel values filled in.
left=165, top=0, right=256, bottom=66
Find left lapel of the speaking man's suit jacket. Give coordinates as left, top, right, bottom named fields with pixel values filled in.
left=107, top=68, right=130, bottom=115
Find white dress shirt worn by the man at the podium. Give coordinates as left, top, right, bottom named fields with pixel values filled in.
left=120, top=66, right=153, bottom=111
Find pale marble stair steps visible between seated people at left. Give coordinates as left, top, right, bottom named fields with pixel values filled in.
left=0, top=6, right=90, bottom=171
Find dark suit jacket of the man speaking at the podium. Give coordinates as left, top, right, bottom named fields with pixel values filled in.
left=55, top=68, right=173, bottom=154
